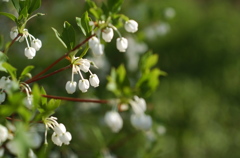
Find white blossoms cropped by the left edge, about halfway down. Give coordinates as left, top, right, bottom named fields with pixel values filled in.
left=0, top=76, right=11, bottom=104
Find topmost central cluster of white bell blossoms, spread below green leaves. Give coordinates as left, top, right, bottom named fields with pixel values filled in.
left=89, top=20, right=138, bottom=55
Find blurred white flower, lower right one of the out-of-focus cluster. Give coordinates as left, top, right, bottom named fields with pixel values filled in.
left=131, top=113, right=152, bottom=130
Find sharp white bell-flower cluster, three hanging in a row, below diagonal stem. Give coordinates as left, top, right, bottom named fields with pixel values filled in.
left=65, top=57, right=100, bottom=94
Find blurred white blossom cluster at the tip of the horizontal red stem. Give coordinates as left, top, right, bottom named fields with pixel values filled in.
left=104, top=96, right=152, bottom=133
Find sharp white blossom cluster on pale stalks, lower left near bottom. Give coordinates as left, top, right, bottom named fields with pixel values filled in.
left=44, top=116, right=72, bottom=146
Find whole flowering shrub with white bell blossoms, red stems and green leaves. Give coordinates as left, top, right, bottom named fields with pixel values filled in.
left=0, top=0, right=165, bottom=157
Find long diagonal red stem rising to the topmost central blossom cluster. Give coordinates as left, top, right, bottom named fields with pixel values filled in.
left=28, top=34, right=95, bottom=82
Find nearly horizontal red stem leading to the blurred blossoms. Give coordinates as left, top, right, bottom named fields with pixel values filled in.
left=42, top=95, right=109, bottom=104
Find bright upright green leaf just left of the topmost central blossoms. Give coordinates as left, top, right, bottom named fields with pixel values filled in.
left=76, top=12, right=91, bottom=36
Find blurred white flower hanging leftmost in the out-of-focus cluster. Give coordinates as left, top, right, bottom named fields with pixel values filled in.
left=104, top=111, right=123, bottom=133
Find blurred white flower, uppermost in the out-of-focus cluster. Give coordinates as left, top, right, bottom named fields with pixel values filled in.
left=129, top=96, right=147, bottom=114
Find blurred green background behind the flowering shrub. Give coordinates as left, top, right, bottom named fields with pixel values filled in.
left=0, top=0, right=240, bottom=158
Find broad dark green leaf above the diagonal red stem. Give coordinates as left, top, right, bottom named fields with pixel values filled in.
left=61, top=21, right=75, bottom=50
